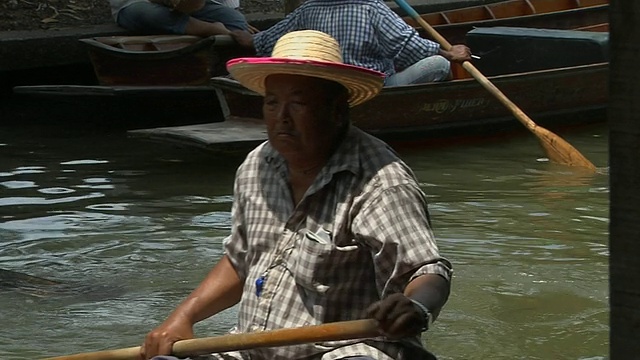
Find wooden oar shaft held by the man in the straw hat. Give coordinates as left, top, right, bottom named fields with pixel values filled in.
left=44, top=319, right=380, bottom=360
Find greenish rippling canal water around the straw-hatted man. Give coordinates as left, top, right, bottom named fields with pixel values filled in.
left=0, top=125, right=609, bottom=360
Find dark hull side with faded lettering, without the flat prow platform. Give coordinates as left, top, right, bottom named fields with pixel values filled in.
left=212, top=63, right=608, bottom=139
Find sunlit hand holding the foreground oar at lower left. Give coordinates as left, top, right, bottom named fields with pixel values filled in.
left=140, top=317, right=193, bottom=360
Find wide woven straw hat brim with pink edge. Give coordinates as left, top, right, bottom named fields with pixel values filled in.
left=227, top=57, right=384, bottom=106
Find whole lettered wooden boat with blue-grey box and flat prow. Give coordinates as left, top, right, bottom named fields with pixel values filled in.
left=131, top=27, right=608, bottom=150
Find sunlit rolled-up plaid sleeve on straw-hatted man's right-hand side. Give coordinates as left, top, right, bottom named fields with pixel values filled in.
left=352, top=184, right=452, bottom=297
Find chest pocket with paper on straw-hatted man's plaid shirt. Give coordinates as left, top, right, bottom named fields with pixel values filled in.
left=289, top=232, right=361, bottom=294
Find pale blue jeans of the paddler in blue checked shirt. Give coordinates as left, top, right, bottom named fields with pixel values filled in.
left=384, top=55, right=451, bottom=86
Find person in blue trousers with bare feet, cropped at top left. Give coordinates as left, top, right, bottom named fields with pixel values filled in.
left=109, top=0, right=249, bottom=37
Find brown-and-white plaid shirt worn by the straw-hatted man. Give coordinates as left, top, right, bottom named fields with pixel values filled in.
left=215, top=126, right=451, bottom=360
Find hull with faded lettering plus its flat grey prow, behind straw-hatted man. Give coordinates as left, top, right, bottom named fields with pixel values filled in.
left=129, top=63, right=609, bottom=153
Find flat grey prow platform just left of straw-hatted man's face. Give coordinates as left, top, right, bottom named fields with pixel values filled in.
left=128, top=116, right=267, bottom=151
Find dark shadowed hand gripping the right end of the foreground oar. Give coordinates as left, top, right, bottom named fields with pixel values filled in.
left=364, top=294, right=426, bottom=339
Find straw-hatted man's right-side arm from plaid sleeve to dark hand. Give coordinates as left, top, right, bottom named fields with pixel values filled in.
left=353, top=183, right=451, bottom=339
